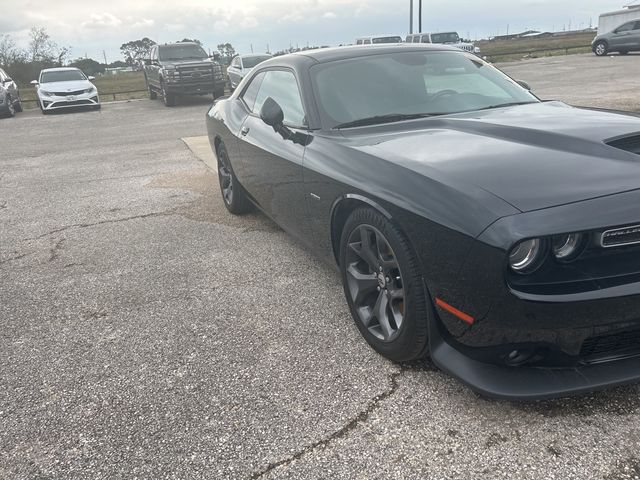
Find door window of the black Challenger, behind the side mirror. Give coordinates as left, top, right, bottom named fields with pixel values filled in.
left=253, top=70, right=306, bottom=127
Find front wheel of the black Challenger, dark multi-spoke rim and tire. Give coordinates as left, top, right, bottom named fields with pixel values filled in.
left=340, top=208, right=432, bottom=362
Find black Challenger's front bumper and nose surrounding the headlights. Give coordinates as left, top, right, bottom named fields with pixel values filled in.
left=427, top=190, right=640, bottom=400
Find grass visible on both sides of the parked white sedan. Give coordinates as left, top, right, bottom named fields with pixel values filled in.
left=20, top=72, right=147, bottom=109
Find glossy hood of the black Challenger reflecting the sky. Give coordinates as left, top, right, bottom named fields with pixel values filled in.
left=342, top=102, right=640, bottom=212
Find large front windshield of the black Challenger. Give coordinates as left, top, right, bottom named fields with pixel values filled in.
left=310, top=51, right=539, bottom=128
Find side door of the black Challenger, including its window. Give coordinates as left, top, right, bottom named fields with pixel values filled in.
left=238, top=69, right=307, bottom=235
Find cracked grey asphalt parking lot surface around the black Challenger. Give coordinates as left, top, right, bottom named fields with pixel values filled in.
left=0, top=56, right=640, bottom=480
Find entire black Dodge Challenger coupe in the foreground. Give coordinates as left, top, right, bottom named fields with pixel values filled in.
left=207, top=44, right=640, bottom=399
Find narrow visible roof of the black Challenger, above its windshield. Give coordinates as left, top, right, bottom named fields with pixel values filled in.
left=291, top=43, right=461, bottom=63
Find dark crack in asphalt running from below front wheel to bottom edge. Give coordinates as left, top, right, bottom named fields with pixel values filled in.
left=249, top=366, right=407, bottom=480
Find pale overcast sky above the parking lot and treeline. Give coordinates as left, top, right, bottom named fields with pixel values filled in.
left=0, top=0, right=631, bottom=62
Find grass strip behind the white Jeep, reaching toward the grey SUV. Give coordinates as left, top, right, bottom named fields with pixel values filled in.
left=476, top=32, right=595, bottom=62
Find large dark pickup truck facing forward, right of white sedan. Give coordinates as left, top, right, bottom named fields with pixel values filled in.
left=144, top=42, right=225, bottom=107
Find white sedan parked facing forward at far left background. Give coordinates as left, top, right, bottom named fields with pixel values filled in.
left=31, top=67, right=100, bottom=114
